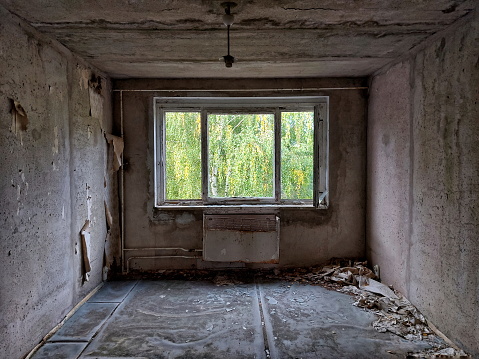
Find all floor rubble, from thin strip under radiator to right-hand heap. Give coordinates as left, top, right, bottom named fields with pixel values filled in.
left=123, top=258, right=471, bottom=359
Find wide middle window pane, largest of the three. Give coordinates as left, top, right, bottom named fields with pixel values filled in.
left=208, top=114, right=274, bottom=197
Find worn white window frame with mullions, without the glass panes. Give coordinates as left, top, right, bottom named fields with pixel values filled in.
left=154, top=96, right=329, bottom=208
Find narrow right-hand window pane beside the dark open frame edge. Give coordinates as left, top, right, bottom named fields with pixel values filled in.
left=281, top=112, right=314, bottom=199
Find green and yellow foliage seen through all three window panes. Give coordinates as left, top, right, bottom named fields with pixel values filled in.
left=165, top=112, right=314, bottom=199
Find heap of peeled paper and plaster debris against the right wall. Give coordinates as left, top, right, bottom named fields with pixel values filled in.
left=268, top=259, right=471, bottom=359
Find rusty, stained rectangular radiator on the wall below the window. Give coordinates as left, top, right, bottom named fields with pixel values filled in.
left=203, top=214, right=279, bottom=263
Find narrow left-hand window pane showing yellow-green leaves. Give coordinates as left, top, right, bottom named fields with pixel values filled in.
left=165, top=112, right=201, bottom=200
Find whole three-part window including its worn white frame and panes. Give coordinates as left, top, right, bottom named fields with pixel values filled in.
left=154, top=97, right=328, bottom=208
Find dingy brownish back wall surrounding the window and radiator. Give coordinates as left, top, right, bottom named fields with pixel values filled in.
left=115, top=79, right=366, bottom=270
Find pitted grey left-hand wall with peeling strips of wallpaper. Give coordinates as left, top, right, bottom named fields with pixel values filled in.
left=0, top=7, right=118, bottom=359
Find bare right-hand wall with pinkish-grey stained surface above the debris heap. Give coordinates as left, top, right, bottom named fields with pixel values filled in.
left=367, top=14, right=479, bottom=356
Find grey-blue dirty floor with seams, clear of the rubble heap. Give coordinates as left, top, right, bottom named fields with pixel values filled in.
left=33, top=280, right=436, bottom=359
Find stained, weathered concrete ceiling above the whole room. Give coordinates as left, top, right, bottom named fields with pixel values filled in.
left=0, top=0, right=477, bottom=78
